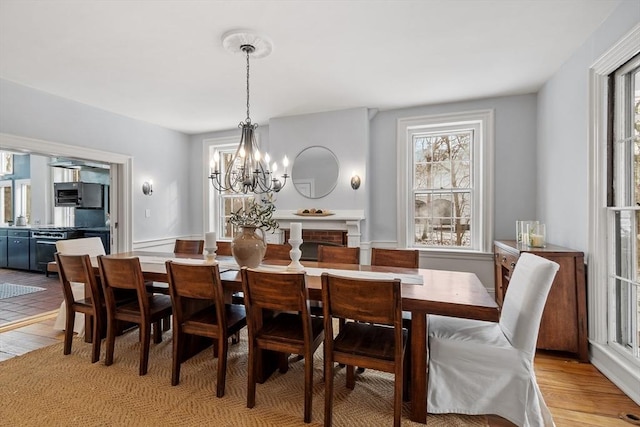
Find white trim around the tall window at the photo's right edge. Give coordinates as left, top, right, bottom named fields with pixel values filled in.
left=587, top=25, right=640, bottom=404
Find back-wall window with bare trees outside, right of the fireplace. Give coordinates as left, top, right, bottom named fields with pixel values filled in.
left=398, top=110, right=493, bottom=252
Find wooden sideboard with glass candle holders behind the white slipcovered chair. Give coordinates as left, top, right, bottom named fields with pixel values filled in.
left=493, top=240, right=589, bottom=362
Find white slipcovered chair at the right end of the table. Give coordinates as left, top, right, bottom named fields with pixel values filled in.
left=427, top=253, right=559, bottom=426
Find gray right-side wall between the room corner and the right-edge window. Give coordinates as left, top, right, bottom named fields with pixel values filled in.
left=536, top=1, right=640, bottom=253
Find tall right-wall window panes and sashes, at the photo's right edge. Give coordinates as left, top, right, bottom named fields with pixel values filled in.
left=607, top=55, right=640, bottom=360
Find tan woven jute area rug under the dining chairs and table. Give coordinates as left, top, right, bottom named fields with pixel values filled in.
left=0, top=331, right=487, bottom=427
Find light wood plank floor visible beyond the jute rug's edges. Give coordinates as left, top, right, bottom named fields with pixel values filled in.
left=0, top=270, right=640, bottom=427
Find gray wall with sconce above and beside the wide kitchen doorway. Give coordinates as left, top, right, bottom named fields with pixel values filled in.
left=0, top=79, right=193, bottom=242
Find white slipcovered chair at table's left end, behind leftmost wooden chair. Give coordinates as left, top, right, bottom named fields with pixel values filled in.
left=53, top=237, right=106, bottom=337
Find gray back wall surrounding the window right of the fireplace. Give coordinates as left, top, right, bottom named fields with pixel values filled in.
left=368, top=94, right=536, bottom=247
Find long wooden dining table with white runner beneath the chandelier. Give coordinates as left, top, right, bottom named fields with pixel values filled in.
left=97, top=251, right=500, bottom=423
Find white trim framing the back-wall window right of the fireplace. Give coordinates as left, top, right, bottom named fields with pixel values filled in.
left=396, top=109, right=495, bottom=254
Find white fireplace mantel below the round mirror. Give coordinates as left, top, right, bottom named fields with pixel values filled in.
left=273, top=209, right=364, bottom=246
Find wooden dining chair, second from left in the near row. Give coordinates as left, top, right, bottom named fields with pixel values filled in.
left=98, top=256, right=171, bottom=375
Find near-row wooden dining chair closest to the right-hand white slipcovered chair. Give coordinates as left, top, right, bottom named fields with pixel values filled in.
left=322, top=273, right=408, bottom=427
